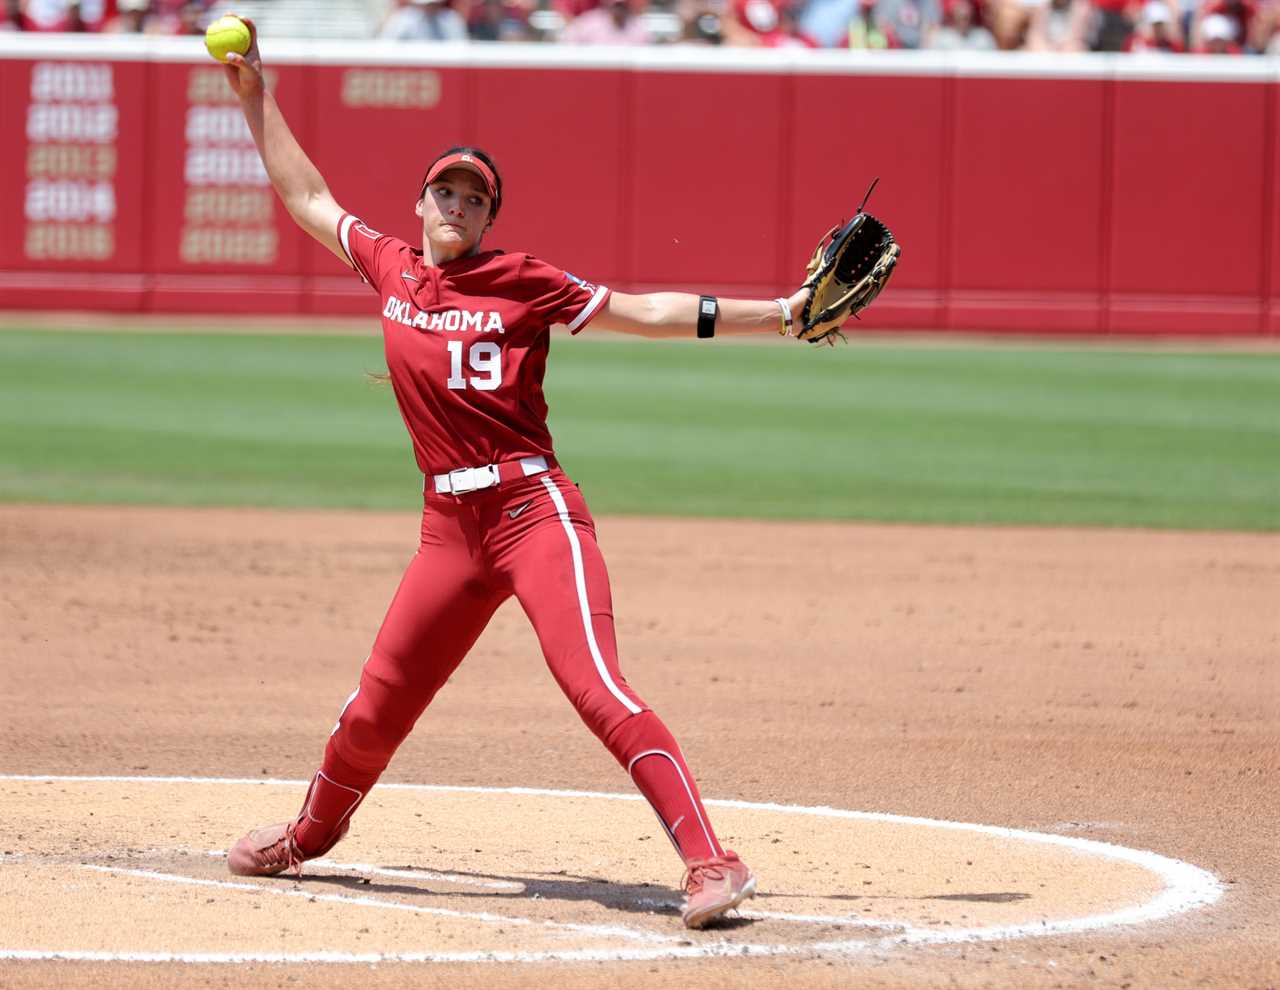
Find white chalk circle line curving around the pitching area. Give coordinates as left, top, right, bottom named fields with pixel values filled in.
left=0, top=774, right=1222, bottom=963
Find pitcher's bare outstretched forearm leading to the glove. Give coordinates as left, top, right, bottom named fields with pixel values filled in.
left=591, top=288, right=809, bottom=337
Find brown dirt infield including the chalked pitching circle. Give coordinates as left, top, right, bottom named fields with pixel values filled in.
left=0, top=506, right=1280, bottom=990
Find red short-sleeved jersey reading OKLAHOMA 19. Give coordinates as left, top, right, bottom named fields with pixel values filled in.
left=338, top=214, right=609, bottom=476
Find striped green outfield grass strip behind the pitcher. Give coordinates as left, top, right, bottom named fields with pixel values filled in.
left=0, top=330, right=1280, bottom=529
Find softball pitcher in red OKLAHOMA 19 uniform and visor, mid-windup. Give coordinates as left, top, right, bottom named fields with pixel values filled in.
left=217, top=24, right=805, bottom=929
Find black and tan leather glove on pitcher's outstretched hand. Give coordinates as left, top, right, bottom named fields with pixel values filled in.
left=796, top=183, right=902, bottom=346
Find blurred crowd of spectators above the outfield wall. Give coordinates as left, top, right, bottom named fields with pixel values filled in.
left=0, top=0, right=1280, bottom=55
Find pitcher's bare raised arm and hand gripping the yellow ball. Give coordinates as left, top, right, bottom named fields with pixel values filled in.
left=225, top=18, right=349, bottom=264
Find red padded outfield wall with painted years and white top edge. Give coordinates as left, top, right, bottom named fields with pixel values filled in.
left=0, top=37, right=1280, bottom=336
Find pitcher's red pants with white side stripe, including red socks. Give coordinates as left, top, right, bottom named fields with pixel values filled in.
left=298, top=469, right=723, bottom=861
